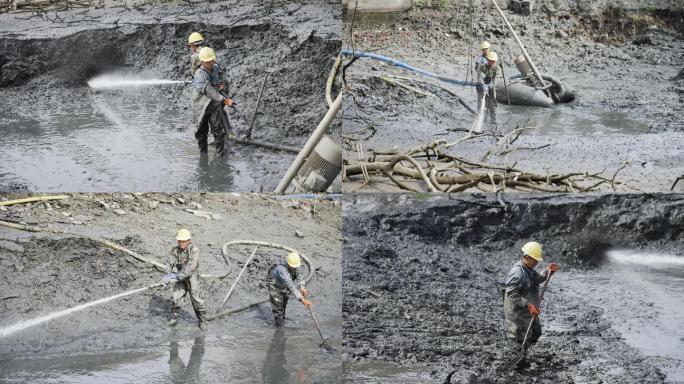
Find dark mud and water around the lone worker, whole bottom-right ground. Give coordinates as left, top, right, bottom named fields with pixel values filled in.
left=342, top=194, right=684, bottom=383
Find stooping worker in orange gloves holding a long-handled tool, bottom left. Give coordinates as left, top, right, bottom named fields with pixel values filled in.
left=266, top=252, right=311, bottom=327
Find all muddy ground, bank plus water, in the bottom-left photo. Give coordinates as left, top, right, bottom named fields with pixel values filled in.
left=0, top=194, right=342, bottom=383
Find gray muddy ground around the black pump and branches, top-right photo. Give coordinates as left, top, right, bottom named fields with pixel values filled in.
left=342, top=1, right=684, bottom=192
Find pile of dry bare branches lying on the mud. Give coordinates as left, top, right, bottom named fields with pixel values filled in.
left=343, top=128, right=627, bottom=192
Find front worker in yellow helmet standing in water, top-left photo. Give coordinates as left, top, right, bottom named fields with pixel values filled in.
left=192, top=47, right=233, bottom=156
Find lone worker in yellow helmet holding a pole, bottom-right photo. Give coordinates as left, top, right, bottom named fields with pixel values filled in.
left=504, top=241, right=558, bottom=345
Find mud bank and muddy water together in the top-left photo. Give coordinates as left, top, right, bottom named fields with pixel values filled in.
left=0, top=1, right=341, bottom=192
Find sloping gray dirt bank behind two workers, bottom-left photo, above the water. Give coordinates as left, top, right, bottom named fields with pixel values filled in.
left=0, top=194, right=341, bottom=358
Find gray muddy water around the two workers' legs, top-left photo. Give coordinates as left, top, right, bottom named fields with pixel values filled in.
left=0, top=72, right=296, bottom=191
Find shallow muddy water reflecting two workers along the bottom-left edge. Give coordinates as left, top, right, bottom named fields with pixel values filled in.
left=0, top=322, right=341, bottom=383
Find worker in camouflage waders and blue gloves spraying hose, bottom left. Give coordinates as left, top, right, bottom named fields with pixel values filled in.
left=162, top=229, right=207, bottom=331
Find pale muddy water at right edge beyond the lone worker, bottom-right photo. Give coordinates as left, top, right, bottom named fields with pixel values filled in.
left=570, top=250, right=684, bottom=382
